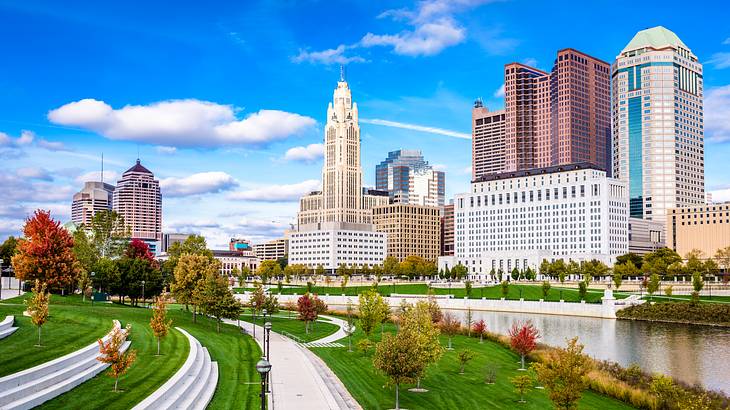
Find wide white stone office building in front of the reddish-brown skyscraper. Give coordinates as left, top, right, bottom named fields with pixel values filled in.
left=446, top=163, right=629, bottom=280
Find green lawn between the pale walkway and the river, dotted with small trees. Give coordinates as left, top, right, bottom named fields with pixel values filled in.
left=312, top=324, right=632, bottom=410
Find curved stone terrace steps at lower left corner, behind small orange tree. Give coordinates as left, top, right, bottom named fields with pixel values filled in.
left=0, top=320, right=131, bottom=410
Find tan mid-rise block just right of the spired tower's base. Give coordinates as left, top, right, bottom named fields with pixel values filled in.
left=373, top=204, right=441, bottom=261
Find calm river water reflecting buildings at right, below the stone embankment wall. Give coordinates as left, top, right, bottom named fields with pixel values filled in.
left=446, top=311, right=730, bottom=393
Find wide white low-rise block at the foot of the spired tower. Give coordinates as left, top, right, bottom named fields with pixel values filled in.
left=289, top=223, right=387, bottom=272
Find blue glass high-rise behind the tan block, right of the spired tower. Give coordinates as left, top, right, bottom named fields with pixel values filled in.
left=375, top=150, right=446, bottom=206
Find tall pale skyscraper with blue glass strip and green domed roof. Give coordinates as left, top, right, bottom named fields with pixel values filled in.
left=612, top=27, right=705, bottom=221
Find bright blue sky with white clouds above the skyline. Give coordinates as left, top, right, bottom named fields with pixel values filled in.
left=0, top=0, right=730, bottom=248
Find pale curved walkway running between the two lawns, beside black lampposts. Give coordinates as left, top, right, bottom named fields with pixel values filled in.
left=224, top=316, right=362, bottom=410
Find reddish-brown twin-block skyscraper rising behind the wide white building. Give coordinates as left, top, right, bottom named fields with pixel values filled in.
left=504, top=48, right=612, bottom=176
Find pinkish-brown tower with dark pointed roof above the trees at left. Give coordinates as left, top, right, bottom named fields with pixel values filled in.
left=113, top=159, right=162, bottom=253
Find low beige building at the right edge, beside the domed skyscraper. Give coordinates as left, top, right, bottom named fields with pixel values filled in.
left=667, top=202, right=730, bottom=257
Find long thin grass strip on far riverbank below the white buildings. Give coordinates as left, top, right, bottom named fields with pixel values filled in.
left=236, top=283, right=628, bottom=303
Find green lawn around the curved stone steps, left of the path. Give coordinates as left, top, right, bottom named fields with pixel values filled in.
left=0, top=295, right=261, bottom=409
